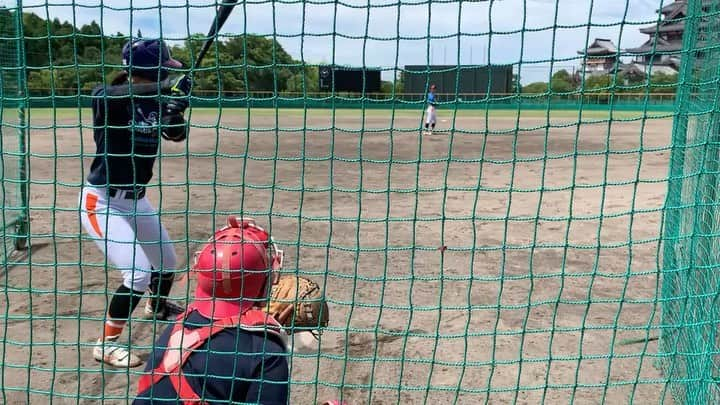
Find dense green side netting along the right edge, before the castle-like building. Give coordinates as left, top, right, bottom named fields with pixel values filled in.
left=660, top=1, right=720, bottom=403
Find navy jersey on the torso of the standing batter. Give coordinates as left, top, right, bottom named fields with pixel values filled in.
left=87, top=85, right=160, bottom=189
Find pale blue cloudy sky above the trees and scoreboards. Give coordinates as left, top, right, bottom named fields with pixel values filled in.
left=5, top=0, right=672, bottom=83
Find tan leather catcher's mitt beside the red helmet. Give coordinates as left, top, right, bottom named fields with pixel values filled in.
left=268, top=275, right=330, bottom=333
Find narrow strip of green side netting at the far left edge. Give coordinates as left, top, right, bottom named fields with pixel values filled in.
left=0, top=3, right=27, bottom=264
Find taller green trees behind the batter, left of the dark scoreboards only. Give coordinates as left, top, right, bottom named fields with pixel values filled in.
left=0, top=9, right=318, bottom=96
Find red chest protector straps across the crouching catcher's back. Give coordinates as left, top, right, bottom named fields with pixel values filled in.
left=138, top=305, right=281, bottom=405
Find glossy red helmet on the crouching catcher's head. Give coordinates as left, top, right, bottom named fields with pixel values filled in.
left=193, top=216, right=283, bottom=319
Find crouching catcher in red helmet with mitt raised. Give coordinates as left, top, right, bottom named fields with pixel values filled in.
left=133, top=216, right=328, bottom=405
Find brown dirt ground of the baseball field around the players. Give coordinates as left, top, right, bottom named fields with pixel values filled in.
left=0, top=110, right=672, bottom=405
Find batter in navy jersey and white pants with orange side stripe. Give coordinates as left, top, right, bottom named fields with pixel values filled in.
left=80, top=39, right=188, bottom=367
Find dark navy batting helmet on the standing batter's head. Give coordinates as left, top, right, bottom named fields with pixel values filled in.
left=122, top=39, right=182, bottom=80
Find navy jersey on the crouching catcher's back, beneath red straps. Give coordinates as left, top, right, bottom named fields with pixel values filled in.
left=133, top=311, right=289, bottom=405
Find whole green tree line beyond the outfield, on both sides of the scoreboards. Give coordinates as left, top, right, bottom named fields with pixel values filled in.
left=0, top=7, right=677, bottom=101
